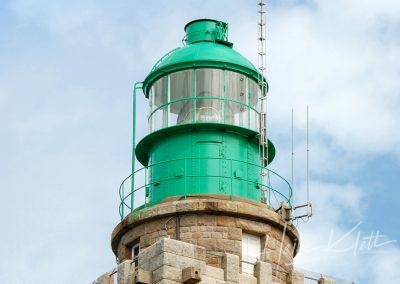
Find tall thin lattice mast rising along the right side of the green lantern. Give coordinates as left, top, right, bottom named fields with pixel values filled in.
left=258, top=0, right=269, bottom=202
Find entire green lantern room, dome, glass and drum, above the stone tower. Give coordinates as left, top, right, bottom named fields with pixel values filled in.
left=136, top=19, right=275, bottom=204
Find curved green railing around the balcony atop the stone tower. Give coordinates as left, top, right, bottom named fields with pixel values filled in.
left=119, top=158, right=292, bottom=220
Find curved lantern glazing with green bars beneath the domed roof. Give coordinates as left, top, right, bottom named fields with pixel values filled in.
left=149, top=68, right=260, bottom=132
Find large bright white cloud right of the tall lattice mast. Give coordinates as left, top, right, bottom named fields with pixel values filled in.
left=269, top=1, right=400, bottom=159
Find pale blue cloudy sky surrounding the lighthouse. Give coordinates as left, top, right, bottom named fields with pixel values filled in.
left=0, top=0, right=400, bottom=284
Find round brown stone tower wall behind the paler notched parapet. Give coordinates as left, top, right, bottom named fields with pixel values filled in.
left=112, top=200, right=297, bottom=283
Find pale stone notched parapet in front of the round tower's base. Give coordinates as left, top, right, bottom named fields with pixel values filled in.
left=96, top=238, right=304, bottom=284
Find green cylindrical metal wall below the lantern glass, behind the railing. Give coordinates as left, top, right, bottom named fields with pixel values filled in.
left=137, top=124, right=272, bottom=204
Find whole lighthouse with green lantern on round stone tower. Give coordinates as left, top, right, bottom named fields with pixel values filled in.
left=101, top=19, right=303, bottom=284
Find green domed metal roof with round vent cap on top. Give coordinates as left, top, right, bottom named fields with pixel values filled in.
left=143, top=19, right=264, bottom=96
